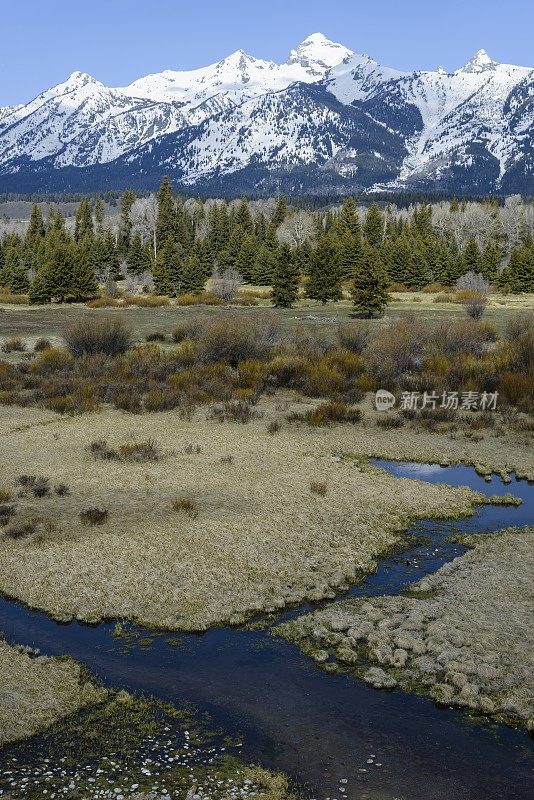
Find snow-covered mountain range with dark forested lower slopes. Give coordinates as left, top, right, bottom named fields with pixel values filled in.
left=0, top=33, right=534, bottom=195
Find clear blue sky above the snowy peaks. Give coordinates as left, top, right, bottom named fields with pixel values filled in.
left=0, top=0, right=534, bottom=106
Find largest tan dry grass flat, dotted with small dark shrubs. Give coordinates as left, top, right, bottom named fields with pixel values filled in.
left=0, top=398, right=488, bottom=630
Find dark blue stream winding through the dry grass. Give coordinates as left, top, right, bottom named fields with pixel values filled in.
left=0, top=462, right=534, bottom=800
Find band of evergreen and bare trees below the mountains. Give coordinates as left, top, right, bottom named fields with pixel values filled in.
left=0, top=178, right=534, bottom=316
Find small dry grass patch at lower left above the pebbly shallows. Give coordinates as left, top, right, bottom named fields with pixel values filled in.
left=0, top=640, right=107, bottom=745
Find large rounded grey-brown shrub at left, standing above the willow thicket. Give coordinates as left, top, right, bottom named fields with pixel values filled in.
left=64, top=316, right=132, bottom=357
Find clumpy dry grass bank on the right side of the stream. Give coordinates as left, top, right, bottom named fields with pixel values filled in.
left=279, top=528, right=534, bottom=732
